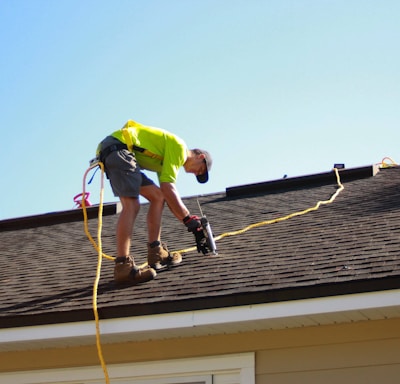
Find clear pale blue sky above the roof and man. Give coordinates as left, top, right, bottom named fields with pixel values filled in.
left=0, top=0, right=400, bottom=219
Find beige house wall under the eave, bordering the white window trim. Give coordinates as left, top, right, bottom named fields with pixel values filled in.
left=0, top=318, right=400, bottom=384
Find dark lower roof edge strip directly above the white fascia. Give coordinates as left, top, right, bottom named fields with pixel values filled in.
left=0, top=276, right=400, bottom=331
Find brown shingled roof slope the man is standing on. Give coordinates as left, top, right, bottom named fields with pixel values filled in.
left=0, top=167, right=400, bottom=327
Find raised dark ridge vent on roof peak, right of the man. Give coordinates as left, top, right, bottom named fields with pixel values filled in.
left=226, top=165, right=379, bottom=197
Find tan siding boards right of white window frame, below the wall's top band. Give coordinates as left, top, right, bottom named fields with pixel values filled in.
left=256, top=339, right=400, bottom=384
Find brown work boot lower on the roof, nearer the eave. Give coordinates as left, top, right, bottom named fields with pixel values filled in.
left=114, top=256, right=157, bottom=285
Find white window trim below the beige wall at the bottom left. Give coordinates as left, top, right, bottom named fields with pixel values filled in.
left=0, top=352, right=255, bottom=384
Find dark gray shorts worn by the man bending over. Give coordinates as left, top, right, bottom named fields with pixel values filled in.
left=101, top=136, right=154, bottom=197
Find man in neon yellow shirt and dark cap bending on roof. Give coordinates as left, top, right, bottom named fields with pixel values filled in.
left=97, top=120, right=212, bottom=284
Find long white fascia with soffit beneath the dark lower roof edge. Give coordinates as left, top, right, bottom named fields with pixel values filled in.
left=0, top=289, right=400, bottom=351
